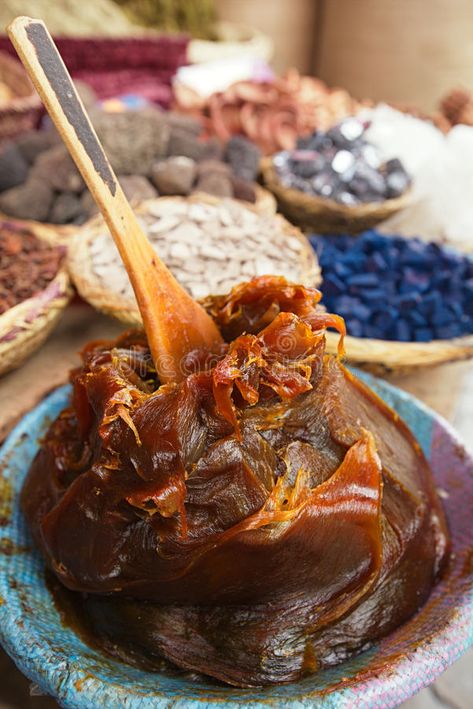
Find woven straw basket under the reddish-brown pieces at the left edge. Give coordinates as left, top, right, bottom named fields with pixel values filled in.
left=0, top=222, right=72, bottom=375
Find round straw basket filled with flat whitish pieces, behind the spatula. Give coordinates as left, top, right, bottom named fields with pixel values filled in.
left=69, top=195, right=320, bottom=316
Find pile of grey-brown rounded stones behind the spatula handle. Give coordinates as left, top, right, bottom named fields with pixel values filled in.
left=0, top=106, right=276, bottom=225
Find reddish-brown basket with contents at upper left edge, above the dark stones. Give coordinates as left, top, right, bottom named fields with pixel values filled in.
left=0, top=52, right=42, bottom=141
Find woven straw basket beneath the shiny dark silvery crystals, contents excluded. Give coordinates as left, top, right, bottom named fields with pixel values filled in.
left=261, top=158, right=411, bottom=234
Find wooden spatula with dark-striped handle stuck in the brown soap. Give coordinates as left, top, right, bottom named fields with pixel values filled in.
left=7, top=17, right=222, bottom=383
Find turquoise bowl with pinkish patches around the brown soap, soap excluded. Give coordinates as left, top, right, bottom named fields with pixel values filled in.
left=0, top=375, right=473, bottom=709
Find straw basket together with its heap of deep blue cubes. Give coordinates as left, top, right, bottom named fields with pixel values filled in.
left=310, top=231, right=473, bottom=373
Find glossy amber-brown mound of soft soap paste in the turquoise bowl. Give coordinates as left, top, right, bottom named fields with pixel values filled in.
left=23, top=278, right=448, bottom=687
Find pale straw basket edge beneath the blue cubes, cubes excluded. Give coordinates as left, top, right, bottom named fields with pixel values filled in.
left=322, top=332, right=473, bottom=375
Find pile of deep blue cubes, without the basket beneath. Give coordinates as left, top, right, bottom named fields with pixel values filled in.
left=309, top=230, right=473, bottom=342
